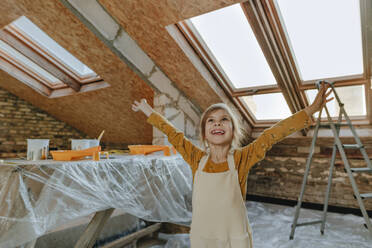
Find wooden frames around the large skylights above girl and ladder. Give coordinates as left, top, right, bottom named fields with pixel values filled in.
left=176, top=0, right=372, bottom=134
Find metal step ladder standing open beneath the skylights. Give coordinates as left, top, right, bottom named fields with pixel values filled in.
left=289, top=81, right=372, bottom=239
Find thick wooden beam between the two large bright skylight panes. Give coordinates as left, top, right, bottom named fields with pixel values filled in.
left=241, top=0, right=307, bottom=135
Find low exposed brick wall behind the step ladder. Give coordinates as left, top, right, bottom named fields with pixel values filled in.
left=247, top=155, right=372, bottom=210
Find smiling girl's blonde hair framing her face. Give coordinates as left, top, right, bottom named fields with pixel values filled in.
left=199, top=103, right=243, bottom=149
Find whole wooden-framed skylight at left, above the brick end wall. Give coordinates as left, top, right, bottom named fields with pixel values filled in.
left=0, top=16, right=110, bottom=98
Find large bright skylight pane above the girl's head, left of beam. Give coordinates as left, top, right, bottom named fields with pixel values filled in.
left=190, top=4, right=276, bottom=88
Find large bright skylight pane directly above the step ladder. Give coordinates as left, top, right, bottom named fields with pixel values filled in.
left=276, top=0, right=363, bottom=81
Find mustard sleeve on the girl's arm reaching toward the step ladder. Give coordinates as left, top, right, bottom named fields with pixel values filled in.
left=240, top=110, right=312, bottom=175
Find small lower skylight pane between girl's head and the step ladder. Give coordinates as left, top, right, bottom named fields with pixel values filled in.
left=241, top=93, right=291, bottom=120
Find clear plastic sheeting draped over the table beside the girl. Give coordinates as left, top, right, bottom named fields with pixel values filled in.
left=0, top=155, right=192, bottom=248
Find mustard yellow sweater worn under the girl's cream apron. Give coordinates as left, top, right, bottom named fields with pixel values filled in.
left=147, top=110, right=311, bottom=200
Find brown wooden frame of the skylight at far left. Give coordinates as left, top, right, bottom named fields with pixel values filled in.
left=0, top=17, right=110, bottom=98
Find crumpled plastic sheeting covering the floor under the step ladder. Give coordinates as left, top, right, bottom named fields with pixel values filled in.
left=151, top=202, right=372, bottom=248
